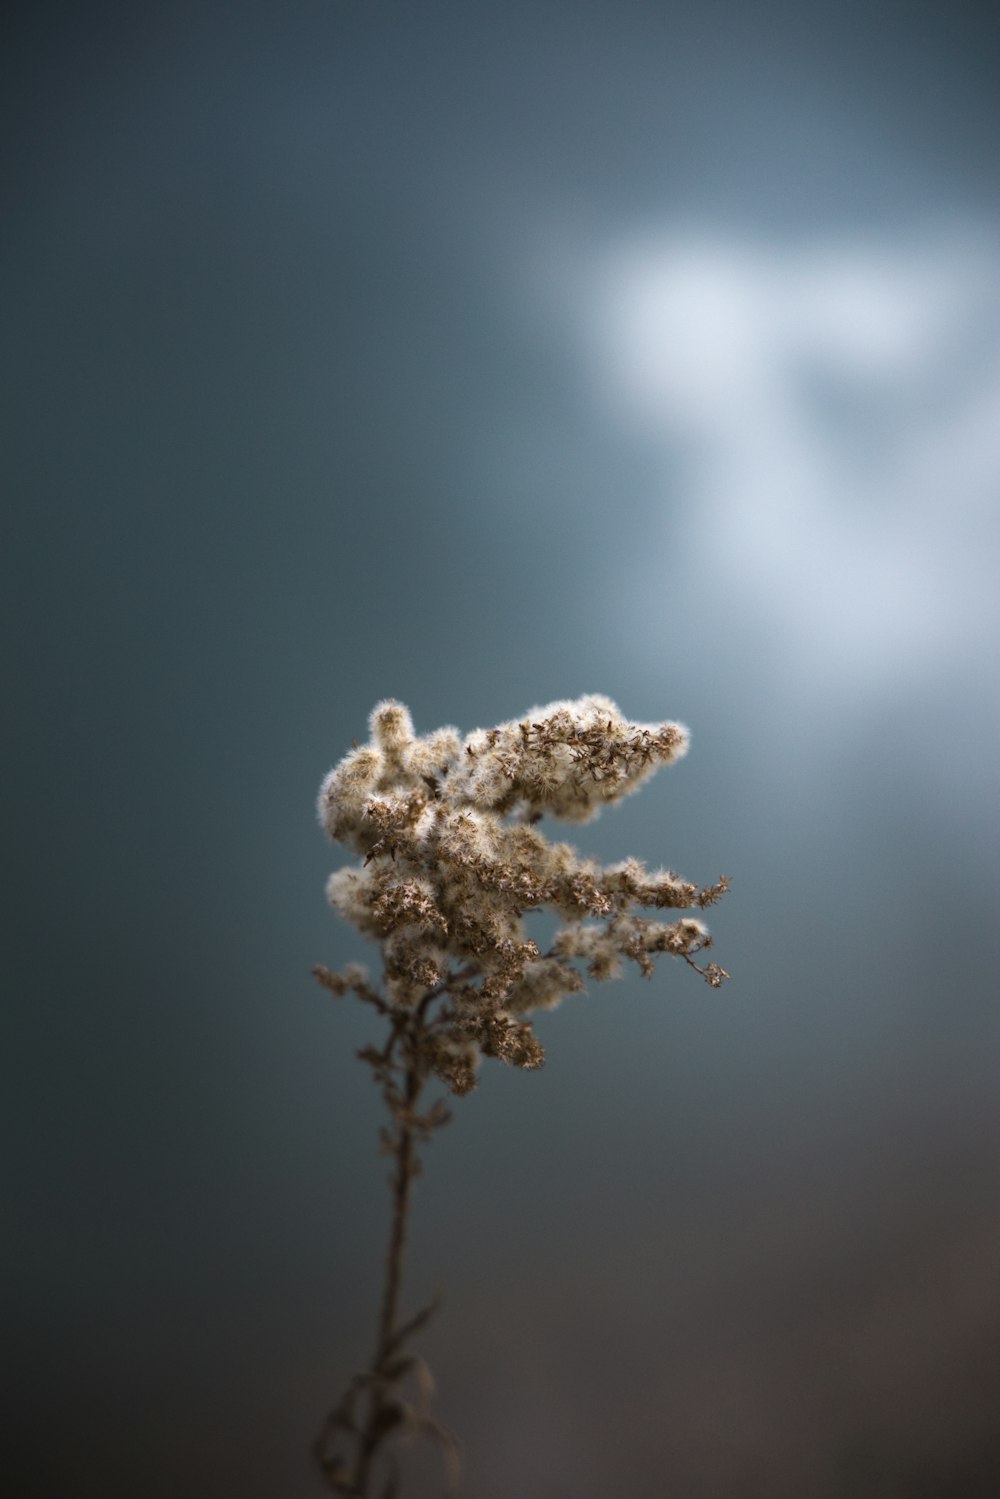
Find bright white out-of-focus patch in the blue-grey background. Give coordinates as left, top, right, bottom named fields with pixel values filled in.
left=576, top=231, right=1000, bottom=697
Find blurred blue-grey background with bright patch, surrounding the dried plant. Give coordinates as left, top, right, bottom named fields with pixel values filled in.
left=7, top=0, right=1000, bottom=1499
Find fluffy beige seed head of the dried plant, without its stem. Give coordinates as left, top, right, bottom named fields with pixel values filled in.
left=316, top=694, right=729, bottom=1094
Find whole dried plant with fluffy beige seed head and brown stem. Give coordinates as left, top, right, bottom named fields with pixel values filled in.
left=315, top=696, right=729, bottom=1499
